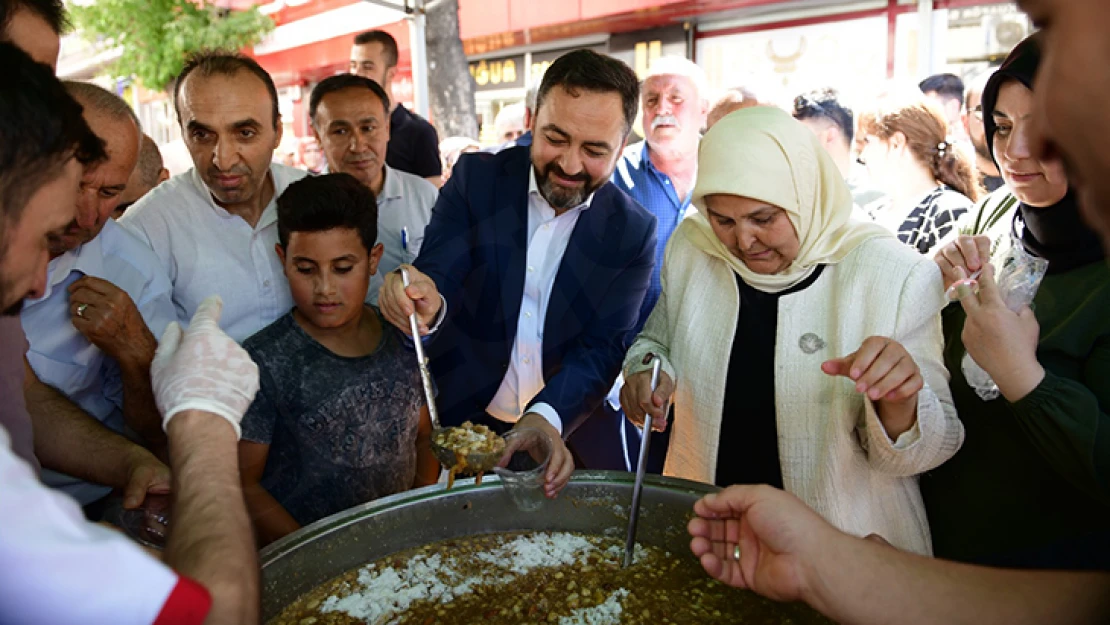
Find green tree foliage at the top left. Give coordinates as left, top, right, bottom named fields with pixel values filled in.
left=69, top=0, right=274, bottom=91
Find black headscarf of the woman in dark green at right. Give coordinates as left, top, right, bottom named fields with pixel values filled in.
left=982, top=33, right=1104, bottom=273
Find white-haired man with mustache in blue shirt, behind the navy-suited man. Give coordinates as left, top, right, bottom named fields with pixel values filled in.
left=568, top=57, right=709, bottom=473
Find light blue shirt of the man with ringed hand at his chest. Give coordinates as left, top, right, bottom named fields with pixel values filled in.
left=20, top=220, right=176, bottom=505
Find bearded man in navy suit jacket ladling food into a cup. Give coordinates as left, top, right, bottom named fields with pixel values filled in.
left=379, top=50, right=655, bottom=497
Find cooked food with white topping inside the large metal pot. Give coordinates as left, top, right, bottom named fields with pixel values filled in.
left=270, top=532, right=828, bottom=625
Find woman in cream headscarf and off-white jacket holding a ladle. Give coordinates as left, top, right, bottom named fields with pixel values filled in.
left=620, top=108, right=963, bottom=554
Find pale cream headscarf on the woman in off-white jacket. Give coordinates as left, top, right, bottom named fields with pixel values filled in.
left=679, top=107, right=892, bottom=293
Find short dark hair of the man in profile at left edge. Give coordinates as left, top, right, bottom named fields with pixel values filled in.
left=0, top=43, right=107, bottom=226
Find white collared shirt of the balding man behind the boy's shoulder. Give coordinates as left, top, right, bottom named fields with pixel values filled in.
left=120, top=163, right=307, bottom=342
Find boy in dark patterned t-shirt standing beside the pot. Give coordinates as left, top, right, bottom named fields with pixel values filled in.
left=239, top=173, right=440, bottom=544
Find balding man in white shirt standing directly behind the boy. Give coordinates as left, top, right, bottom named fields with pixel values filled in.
left=119, top=53, right=306, bottom=342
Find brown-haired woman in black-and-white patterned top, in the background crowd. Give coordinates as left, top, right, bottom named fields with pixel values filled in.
left=859, top=95, right=980, bottom=254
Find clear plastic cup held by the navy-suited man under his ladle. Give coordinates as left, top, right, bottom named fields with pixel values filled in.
left=493, top=427, right=552, bottom=512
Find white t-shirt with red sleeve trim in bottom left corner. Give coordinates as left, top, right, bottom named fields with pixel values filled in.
left=0, top=427, right=211, bottom=625
